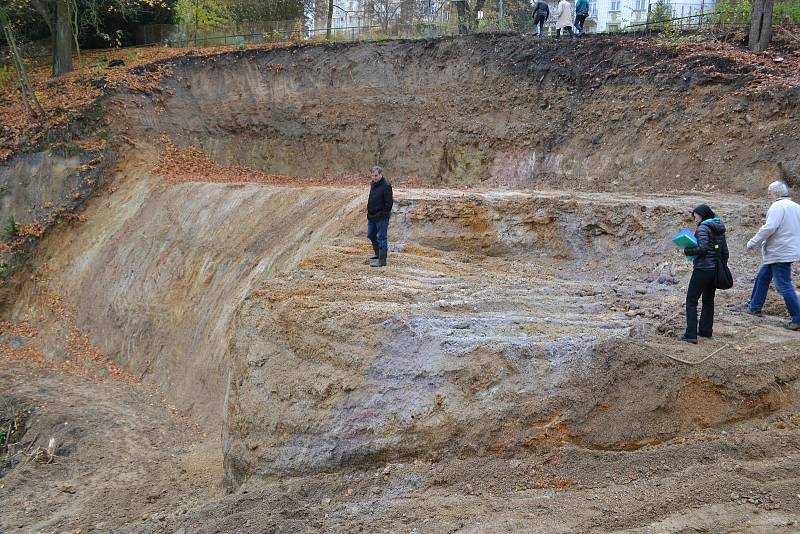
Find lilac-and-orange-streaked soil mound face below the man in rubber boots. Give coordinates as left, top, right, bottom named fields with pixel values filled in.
left=223, top=191, right=798, bottom=485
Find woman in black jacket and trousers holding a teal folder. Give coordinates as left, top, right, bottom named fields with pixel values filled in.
left=681, top=204, right=728, bottom=343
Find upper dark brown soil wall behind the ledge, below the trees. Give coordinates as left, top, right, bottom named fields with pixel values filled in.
left=114, top=35, right=800, bottom=192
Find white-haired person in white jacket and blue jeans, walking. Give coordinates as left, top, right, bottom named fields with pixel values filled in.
left=747, top=182, right=800, bottom=330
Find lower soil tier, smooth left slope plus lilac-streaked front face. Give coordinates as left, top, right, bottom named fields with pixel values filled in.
left=12, top=159, right=794, bottom=494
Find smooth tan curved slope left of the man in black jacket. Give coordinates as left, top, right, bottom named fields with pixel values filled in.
left=7, top=157, right=364, bottom=421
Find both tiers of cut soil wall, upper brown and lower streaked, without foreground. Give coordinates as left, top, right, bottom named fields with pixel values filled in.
left=0, top=36, right=800, bottom=496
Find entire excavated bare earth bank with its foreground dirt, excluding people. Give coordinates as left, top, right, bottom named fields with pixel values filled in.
left=0, top=35, right=800, bottom=533
